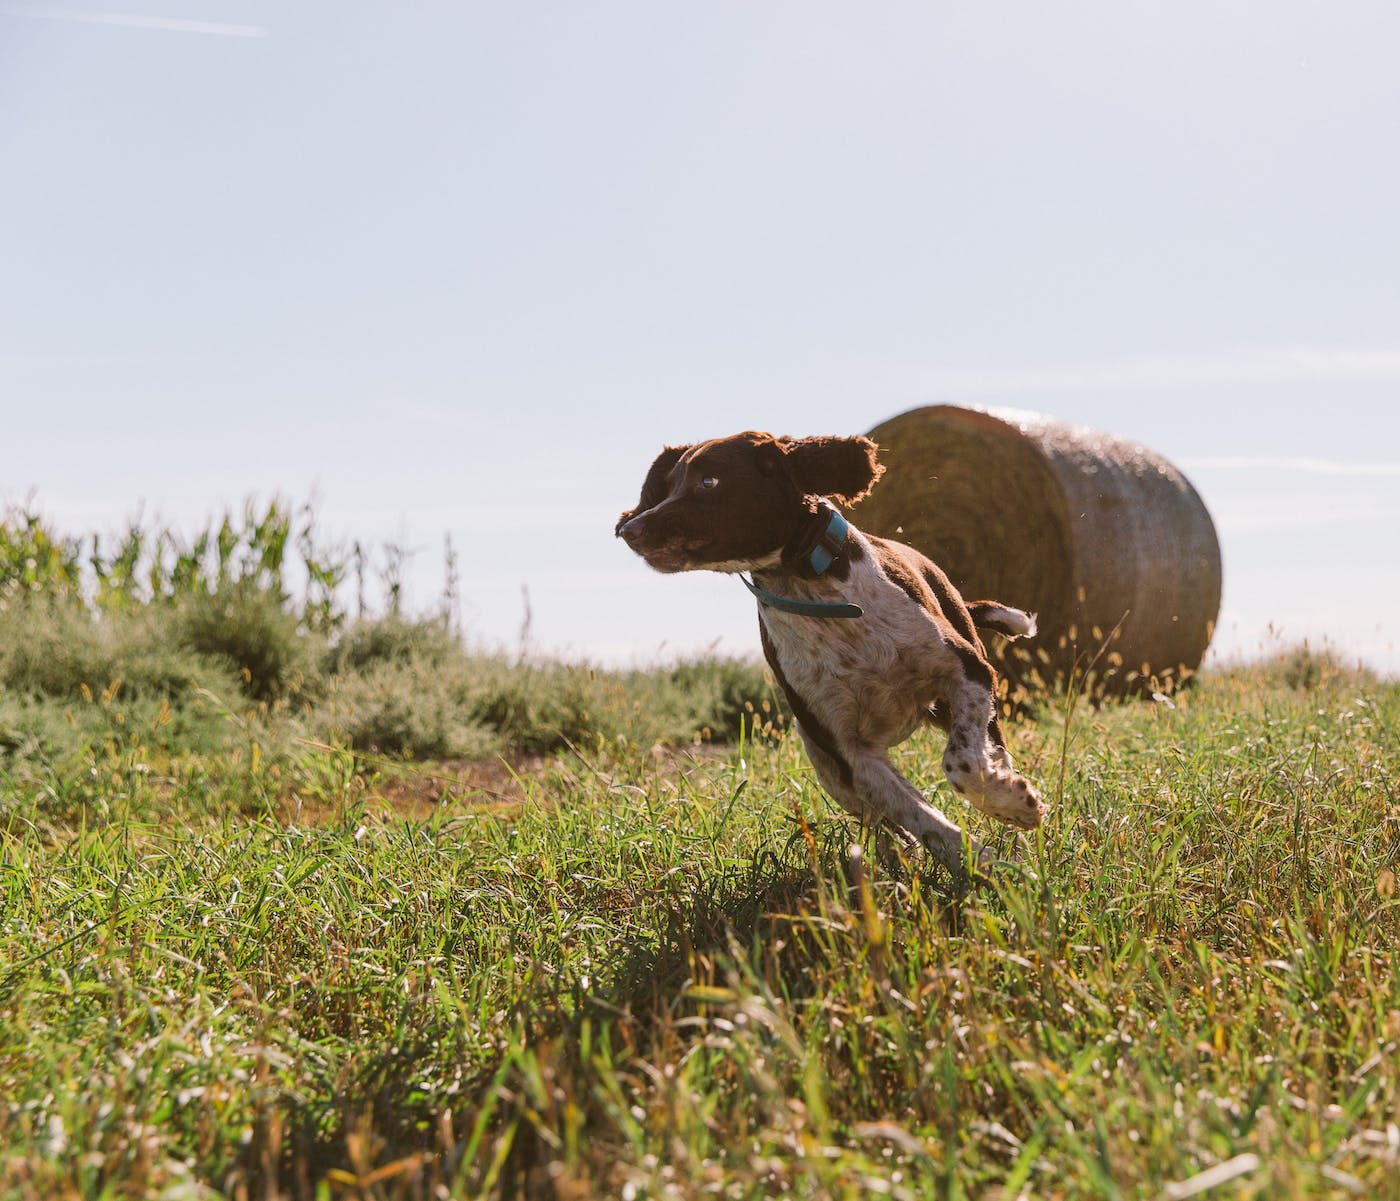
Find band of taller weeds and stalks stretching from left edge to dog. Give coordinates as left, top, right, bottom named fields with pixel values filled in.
left=0, top=501, right=787, bottom=760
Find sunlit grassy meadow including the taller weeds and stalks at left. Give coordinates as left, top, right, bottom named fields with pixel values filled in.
left=0, top=504, right=1400, bottom=1201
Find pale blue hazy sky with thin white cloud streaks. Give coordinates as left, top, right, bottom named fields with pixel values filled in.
left=0, top=0, right=1400, bottom=670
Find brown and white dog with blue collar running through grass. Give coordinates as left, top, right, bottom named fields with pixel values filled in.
left=616, top=431, right=1044, bottom=883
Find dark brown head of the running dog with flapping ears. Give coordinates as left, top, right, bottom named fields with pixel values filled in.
left=616, top=430, right=885, bottom=571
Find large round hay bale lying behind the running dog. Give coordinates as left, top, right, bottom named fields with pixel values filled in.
left=853, top=405, right=1221, bottom=693
